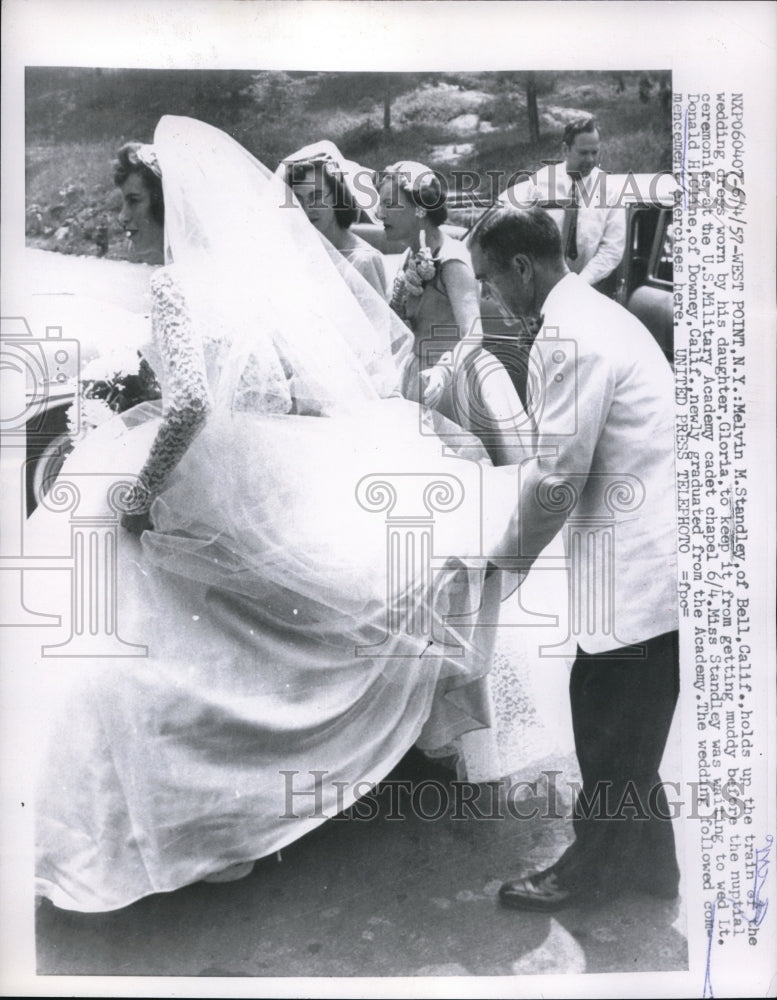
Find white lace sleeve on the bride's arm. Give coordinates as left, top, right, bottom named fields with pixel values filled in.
left=123, top=269, right=211, bottom=514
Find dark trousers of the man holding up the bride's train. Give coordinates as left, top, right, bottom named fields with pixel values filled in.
left=550, top=632, right=680, bottom=897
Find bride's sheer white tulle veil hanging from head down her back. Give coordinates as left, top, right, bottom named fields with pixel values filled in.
left=154, top=116, right=412, bottom=415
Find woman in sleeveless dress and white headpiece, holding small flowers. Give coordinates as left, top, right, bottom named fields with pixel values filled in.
left=378, top=160, right=524, bottom=465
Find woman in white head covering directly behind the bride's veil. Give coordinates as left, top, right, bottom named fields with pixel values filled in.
left=281, top=141, right=388, bottom=299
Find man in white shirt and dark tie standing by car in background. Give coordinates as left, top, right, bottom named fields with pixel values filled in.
left=500, top=115, right=626, bottom=291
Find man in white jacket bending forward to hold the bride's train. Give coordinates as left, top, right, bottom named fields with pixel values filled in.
left=470, top=206, right=679, bottom=910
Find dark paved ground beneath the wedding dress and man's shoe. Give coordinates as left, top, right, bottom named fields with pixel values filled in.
left=37, top=753, right=687, bottom=989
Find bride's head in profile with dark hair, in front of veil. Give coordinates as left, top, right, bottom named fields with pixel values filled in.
left=113, top=142, right=165, bottom=264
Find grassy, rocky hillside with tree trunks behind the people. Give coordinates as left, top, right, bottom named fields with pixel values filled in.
left=26, top=68, right=671, bottom=257
